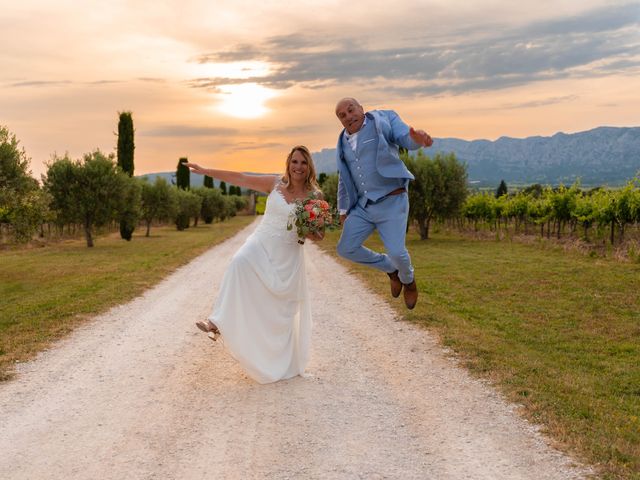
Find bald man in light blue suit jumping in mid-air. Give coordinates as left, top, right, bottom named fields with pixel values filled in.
left=336, top=98, right=433, bottom=309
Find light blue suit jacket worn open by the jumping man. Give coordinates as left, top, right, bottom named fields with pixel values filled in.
left=336, top=110, right=421, bottom=212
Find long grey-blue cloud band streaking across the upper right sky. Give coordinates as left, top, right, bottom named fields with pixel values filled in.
left=189, top=2, right=640, bottom=97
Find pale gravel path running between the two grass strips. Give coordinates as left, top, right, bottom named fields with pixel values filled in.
left=0, top=224, right=588, bottom=480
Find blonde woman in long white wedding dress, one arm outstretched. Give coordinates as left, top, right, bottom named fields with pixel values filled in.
left=186, top=146, right=323, bottom=383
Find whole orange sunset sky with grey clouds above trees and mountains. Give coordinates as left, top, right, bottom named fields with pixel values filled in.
left=0, top=0, right=640, bottom=178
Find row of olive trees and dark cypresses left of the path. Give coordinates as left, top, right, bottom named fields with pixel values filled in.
left=0, top=118, right=247, bottom=247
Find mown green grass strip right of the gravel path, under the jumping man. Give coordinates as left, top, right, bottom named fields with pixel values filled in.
left=321, top=232, right=640, bottom=479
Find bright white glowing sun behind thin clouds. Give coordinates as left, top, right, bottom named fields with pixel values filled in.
left=217, top=83, right=277, bottom=118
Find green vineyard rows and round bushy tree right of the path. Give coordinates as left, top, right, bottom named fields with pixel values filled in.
left=319, top=150, right=640, bottom=245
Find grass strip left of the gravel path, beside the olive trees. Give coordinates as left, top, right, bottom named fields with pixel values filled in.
left=0, top=216, right=254, bottom=380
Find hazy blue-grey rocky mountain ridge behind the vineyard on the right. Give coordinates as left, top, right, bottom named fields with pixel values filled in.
left=313, top=127, right=640, bottom=185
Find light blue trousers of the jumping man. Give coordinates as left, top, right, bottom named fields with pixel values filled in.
left=338, top=192, right=413, bottom=284
